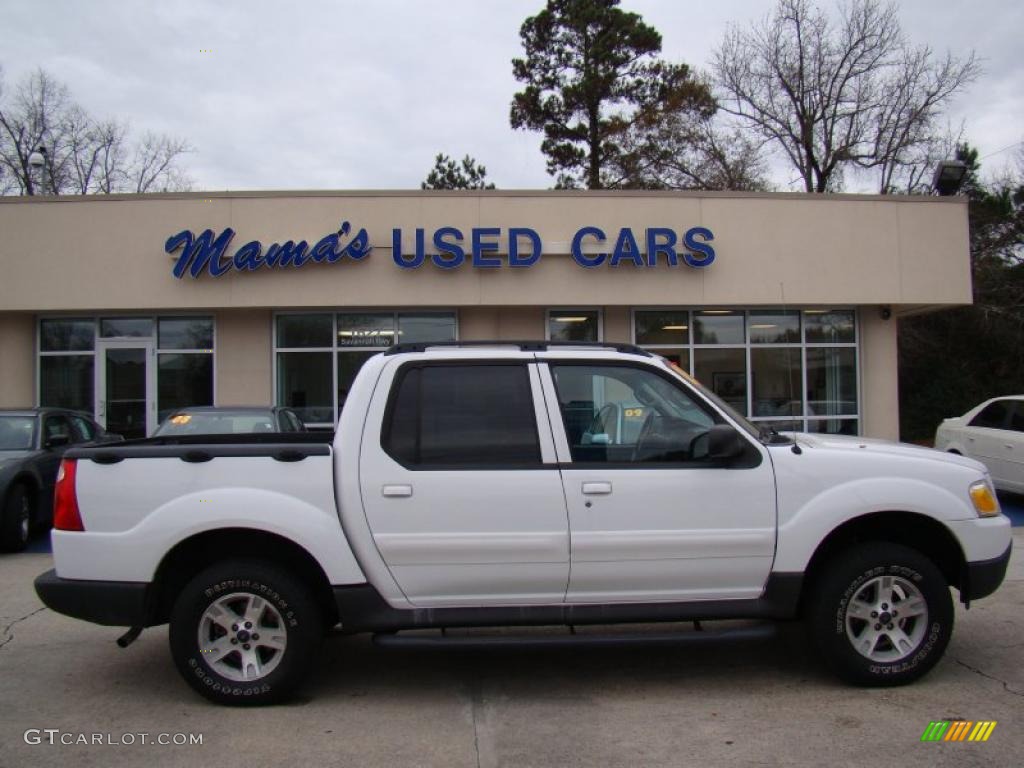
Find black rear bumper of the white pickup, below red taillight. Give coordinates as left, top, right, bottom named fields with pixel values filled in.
left=36, top=570, right=150, bottom=627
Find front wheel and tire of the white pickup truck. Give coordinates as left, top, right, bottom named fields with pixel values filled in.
left=806, top=542, right=953, bottom=686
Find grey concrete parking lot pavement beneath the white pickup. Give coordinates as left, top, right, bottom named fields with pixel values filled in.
left=0, top=529, right=1024, bottom=768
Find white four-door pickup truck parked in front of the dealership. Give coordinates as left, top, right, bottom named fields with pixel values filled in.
left=29, top=342, right=1011, bottom=703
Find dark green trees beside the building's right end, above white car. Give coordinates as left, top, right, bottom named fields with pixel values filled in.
left=899, top=144, right=1024, bottom=440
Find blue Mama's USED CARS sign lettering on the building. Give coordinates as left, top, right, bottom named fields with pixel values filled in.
left=164, top=221, right=715, bottom=280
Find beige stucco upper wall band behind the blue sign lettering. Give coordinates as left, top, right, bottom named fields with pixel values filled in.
left=0, top=191, right=971, bottom=312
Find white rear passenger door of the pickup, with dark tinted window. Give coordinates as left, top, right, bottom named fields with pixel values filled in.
left=359, top=354, right=569, bottom=606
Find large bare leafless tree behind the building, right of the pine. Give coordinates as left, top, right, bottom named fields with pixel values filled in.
left=714, top=0, right=980, bottom=193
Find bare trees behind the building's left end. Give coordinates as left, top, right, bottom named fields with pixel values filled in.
left=0, top=70, right=191, bottom=195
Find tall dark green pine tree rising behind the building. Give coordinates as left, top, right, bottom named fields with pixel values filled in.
left=510, top=0, right=716, bottom=189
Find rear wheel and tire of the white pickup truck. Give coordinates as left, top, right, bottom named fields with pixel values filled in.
left=170, top=560, right=324, bottom=706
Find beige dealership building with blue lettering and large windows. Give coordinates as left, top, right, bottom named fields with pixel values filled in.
left=0, top=190, right=971, bottom=438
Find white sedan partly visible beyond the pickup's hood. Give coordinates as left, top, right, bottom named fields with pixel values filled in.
left=935, top=394, right=1024, bottom=494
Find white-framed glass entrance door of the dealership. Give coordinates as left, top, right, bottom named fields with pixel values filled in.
left=96, top=340, right=157, bottom=440
